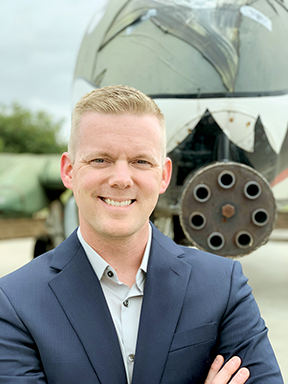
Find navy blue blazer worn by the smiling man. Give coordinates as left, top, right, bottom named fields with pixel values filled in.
left=0, top=226, right=283, bottom=384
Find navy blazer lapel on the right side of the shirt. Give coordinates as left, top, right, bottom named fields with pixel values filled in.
left=133, top=226, right=191, bottom=384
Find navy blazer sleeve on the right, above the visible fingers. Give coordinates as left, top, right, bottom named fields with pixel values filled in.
left=218, top=261, right=283, bottom=384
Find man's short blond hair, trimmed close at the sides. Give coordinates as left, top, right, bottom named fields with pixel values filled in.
left=68, top=85, right=166, bottom=163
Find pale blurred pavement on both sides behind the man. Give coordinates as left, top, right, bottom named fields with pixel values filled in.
left=0, top=229, right=288, bottom=384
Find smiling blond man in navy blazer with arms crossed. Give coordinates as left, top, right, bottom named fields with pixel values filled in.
left=0, top=86, right=282, bottom=384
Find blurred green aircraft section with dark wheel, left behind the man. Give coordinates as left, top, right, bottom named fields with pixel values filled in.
left=0, top=153, right=66, bottom=257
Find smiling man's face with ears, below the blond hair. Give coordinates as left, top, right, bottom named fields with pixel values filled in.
left=61, top=112, right=171, bottom=240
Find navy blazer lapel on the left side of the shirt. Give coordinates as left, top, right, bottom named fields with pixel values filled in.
left=49, top=232, right=127, bottom=384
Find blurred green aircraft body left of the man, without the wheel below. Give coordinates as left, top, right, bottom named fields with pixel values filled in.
left=0, top=153, right=65, bottom=217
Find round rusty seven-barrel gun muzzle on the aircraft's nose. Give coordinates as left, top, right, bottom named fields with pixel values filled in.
left=180, top=162, right=276, bottom=257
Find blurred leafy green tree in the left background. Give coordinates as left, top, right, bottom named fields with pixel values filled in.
left=0, top=103, right=66, bottom=153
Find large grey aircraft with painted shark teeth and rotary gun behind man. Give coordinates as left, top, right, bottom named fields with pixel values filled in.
left=0, top=0, right=288, bottom=257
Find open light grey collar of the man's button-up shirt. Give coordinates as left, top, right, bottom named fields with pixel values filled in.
left=77, top=223, right=152, bottom=285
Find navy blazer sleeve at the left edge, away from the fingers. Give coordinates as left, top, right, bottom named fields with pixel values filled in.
left=0, top=288, right=47, bottom=384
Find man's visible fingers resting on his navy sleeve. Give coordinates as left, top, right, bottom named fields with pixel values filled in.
left=204, top=355, right=250, bottom=384
